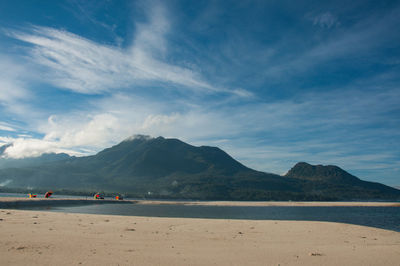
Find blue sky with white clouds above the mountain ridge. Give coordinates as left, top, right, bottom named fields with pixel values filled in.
left=0, top=0, right=400, bottom=186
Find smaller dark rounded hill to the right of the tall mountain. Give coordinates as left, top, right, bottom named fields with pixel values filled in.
left=285, top=162, right=400, bottom=199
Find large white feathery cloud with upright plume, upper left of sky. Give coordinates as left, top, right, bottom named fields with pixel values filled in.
left=10, top=2, right=250, bottom=96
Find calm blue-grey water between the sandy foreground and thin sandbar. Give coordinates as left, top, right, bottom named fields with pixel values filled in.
left=34, top=204, right=400, bottom=232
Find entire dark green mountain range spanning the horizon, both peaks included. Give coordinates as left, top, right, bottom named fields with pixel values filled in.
left=0, top=136, right=400, bottom=200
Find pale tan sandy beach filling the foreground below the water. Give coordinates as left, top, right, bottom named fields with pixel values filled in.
left=0, top=198, right=400, bottom=265
